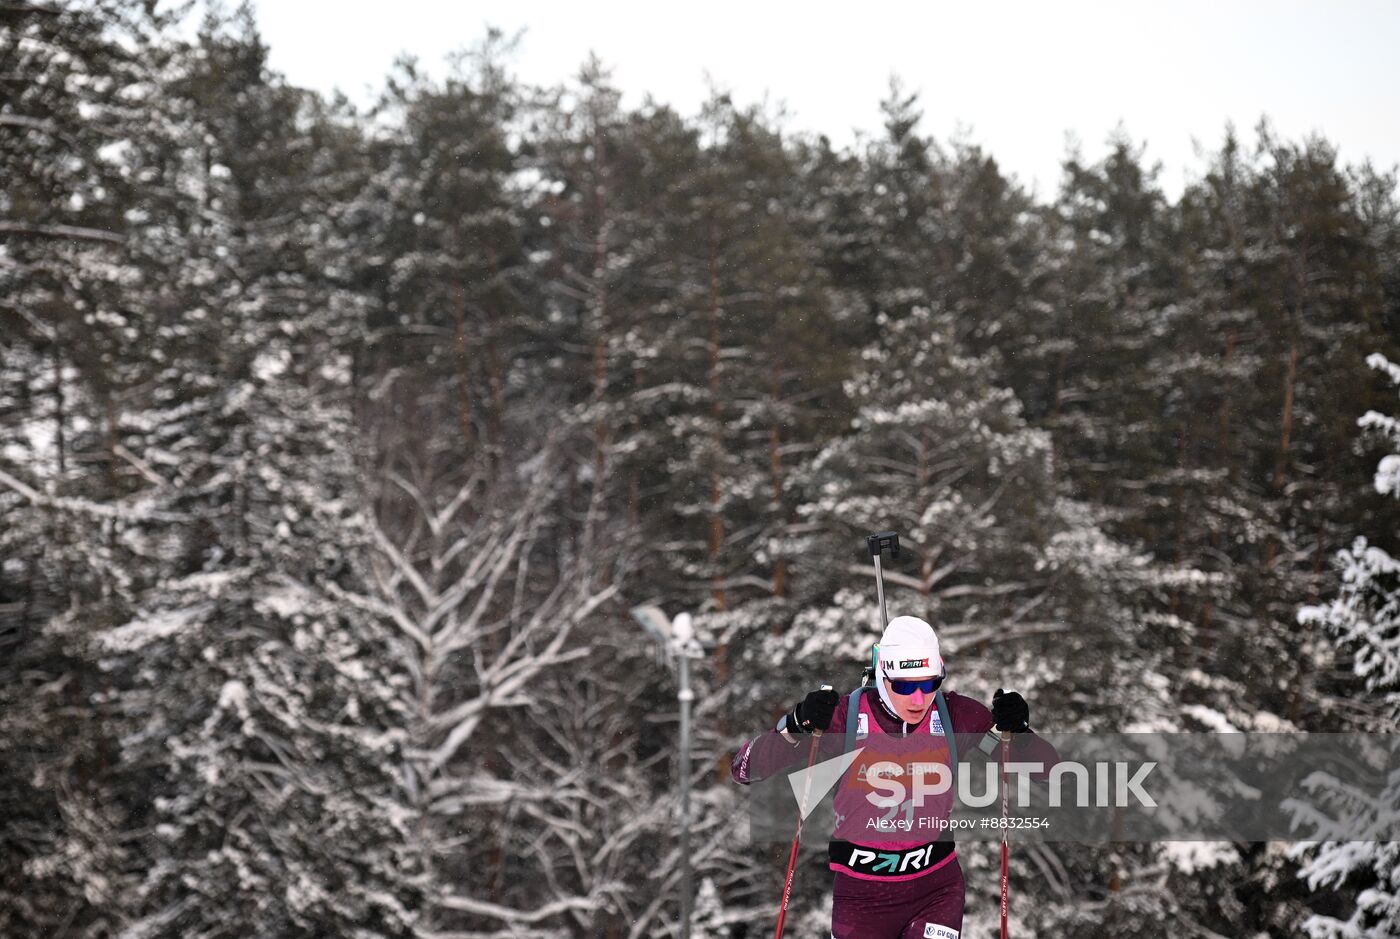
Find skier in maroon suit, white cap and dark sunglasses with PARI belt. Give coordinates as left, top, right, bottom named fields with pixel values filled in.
left=731, top=616, right=1058, bottom=939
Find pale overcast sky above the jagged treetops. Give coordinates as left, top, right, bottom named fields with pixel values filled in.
left=246, top=0, right=1400, bottom=196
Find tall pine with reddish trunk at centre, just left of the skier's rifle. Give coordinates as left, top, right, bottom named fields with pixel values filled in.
left=616, top=92, right=848, bottom=934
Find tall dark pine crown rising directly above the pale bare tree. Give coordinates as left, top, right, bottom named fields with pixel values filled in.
left=343, top=32, right=528, bottom=470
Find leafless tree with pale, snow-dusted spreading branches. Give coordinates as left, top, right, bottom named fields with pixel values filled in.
left=343, top=442, right=632, bottom=939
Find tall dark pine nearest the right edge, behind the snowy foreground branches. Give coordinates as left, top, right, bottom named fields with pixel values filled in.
left=1218, top=126, right=1387, bottom=728
